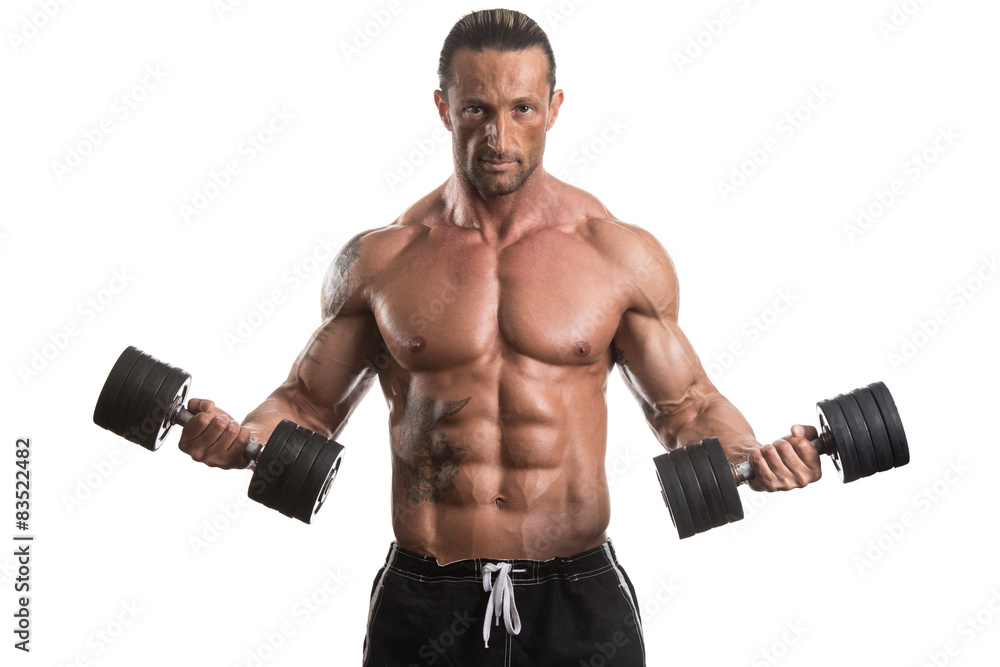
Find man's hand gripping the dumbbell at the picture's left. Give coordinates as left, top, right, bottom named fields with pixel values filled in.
left=178, top=398, right=250, bottom=468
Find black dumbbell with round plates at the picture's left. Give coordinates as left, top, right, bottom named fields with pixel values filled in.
left=94, top=347, right=344, bottom=523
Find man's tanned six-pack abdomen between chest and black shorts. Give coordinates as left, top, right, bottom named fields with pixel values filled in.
left=391, top=383, right=611, bottom=564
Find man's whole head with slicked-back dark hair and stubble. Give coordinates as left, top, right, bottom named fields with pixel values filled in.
left=434, top=9, right=563, bottom=196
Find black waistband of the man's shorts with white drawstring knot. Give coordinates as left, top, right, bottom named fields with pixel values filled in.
left=386, top=539, right=618, bottom=585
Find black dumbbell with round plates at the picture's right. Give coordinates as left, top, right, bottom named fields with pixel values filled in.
left=653, top=382, right=910, bottom=539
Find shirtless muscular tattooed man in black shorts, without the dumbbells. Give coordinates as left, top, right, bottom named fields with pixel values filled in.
left=181, top=10, right=820, bottom=667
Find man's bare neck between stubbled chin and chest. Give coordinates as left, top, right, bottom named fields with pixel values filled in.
left=442, top=164, right=553, bottom=240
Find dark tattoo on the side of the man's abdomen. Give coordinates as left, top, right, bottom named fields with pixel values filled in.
left=396, top=378, right=472, bottom=503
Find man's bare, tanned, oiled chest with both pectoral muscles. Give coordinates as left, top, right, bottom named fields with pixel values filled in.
left=373, top=233, right=625, bottom=372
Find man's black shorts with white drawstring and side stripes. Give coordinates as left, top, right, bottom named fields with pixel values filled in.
left=363, top=540, right=646, bottom=667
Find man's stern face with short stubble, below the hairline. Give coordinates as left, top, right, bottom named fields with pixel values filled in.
left=434, top=47, right=563, bottom=196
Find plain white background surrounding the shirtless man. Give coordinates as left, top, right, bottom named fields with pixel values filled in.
left=0, top=0, right=1000, bottom=666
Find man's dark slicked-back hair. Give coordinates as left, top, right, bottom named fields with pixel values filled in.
left=438, top=9, right=556, bottom=100
